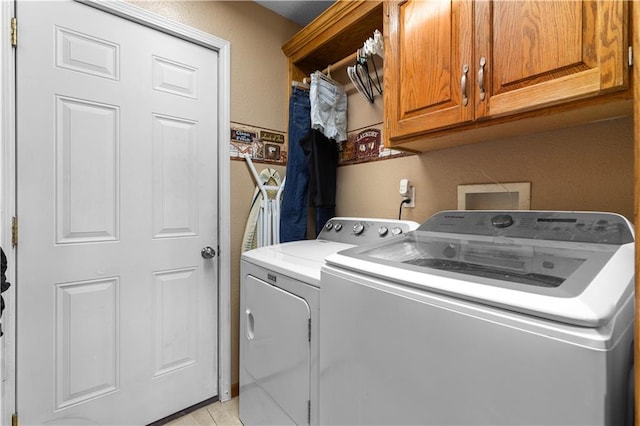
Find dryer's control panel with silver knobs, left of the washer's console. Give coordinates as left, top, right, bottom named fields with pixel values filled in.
left=317, top=217, right=420, bottom=245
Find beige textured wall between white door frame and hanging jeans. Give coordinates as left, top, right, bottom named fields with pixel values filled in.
left=132, top=0, right=300, bottom=391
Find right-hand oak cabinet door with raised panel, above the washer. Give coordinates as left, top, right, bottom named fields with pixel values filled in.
left=473, top=0, right=628, bottom=118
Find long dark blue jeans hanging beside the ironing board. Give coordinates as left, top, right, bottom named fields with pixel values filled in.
left=280, top=87, right=311, bottom=243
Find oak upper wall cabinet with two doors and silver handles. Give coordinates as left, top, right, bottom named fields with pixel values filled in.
left=384, top=0, right=629, bottom=150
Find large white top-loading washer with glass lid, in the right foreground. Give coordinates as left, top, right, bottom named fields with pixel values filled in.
left=319, top=211, right=634, bottom=425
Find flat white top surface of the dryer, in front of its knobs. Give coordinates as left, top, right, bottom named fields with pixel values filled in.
left=241, top=240, right=353, bottom=287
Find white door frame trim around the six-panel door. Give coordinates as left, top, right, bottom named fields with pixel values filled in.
left=0, top=0, right=231, bottom=424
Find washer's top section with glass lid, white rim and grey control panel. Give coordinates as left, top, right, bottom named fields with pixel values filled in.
left=327, top=211, right=634, bottom=326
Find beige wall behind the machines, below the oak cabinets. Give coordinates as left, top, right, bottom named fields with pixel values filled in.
left=336, top=118, right=633, bottom=222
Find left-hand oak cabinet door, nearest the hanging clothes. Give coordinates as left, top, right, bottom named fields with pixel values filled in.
left=384, top=0, right=474, bottom=146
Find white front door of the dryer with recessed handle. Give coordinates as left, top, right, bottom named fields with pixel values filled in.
left=240, top=275, right=311, bottom=425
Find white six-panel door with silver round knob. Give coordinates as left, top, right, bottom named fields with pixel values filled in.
left=16, top=1, right=218, bottom=424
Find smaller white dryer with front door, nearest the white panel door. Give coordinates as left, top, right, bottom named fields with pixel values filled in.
left=239, top=217, right=418, bottom=425
